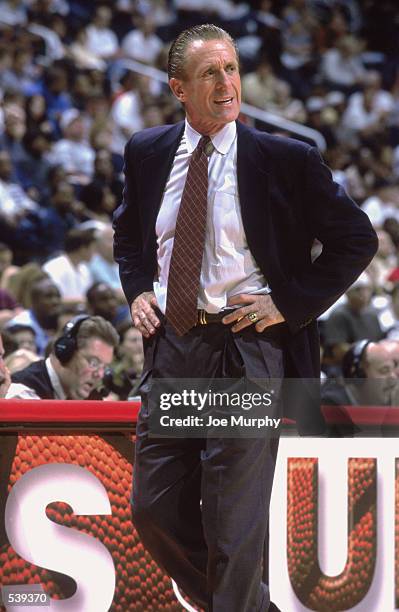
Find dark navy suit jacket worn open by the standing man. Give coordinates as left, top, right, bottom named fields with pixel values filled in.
left=114, top=122, right=378, bottom=388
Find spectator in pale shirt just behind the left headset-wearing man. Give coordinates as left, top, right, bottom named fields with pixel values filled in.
left=6, top=277, right=61, bottom=356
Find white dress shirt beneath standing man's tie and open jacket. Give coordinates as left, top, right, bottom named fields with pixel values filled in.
left=154, top=121, right=270, bottom=313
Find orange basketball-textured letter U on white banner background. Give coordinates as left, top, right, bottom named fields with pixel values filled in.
left=287, top=458, right=378, bottom=612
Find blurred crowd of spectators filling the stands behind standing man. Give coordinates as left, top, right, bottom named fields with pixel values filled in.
left=0, top=0, right=399, bottom=406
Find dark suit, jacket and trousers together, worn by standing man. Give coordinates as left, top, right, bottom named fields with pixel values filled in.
left=114, top=117, right=377, bottom=612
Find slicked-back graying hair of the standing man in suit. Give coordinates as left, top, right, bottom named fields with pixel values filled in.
left=168, top=23, right=238, bottom=79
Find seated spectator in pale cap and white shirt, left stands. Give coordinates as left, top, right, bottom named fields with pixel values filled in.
left=49, top=108, right=94, bottom=184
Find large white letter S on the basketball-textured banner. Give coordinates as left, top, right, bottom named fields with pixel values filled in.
left=5, top=463, right=115, bottom=612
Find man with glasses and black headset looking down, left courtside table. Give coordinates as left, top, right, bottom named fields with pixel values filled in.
left=6, top=315, right=119, bottom=400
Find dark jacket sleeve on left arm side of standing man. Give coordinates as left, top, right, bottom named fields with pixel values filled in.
left=113, top=136, right=153, bottom=305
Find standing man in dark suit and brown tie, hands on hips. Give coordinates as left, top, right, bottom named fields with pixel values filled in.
left=114, top=25, right=377, bottom=612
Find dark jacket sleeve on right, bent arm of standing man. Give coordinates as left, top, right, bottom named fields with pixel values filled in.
left=273, top=147, right=378, bottom=333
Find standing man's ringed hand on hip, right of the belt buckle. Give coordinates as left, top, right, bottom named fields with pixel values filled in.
left=223, top=293, right=285, bottom=332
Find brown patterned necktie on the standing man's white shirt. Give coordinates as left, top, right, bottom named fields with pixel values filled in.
left=166, top=136, right=210, bottom=336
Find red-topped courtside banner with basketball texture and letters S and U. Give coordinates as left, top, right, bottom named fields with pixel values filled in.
left=0, top=402, right=399, bottom=612
